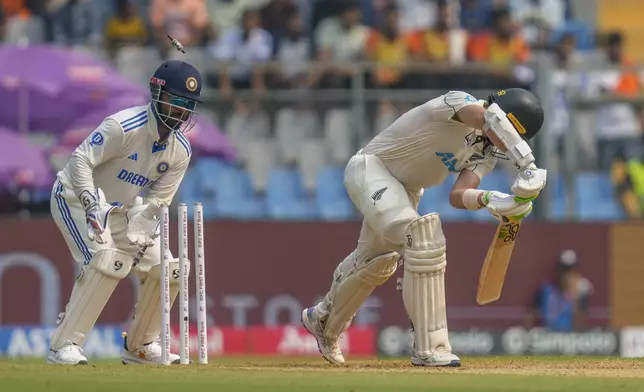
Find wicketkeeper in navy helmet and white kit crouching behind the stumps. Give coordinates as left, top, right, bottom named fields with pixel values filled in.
left=47, top=60, right=202, bottom=364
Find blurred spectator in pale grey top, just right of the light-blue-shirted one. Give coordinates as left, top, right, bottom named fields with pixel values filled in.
left=271, top=7, right=311, bottom=88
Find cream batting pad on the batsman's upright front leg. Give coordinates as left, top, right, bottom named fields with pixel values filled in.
left=402, top=214, right=451, bottom=358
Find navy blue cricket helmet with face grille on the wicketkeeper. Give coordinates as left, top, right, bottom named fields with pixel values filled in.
left=150, top=60, right=202, bottom=132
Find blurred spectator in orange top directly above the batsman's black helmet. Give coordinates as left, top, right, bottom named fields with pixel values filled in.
left=468, top=8, right=530, bottom=67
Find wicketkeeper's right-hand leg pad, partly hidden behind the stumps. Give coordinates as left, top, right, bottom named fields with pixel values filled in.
left=127, top=259, right=185, bottom=351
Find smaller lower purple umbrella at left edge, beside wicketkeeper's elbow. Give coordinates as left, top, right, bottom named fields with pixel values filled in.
left=0, top=127, right=53, bottom=187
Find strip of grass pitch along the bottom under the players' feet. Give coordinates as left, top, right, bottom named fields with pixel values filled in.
left=0, top=357, right=644, bottom=392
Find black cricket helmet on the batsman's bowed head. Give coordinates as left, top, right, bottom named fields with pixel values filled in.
left=487, top=88, right=543, bottom=140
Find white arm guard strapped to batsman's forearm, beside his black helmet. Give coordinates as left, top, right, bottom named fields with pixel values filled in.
left=484, top=103, right=534, bottom=168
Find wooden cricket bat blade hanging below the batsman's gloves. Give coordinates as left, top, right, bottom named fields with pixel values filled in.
left=476, top=221, right=521, bottom=305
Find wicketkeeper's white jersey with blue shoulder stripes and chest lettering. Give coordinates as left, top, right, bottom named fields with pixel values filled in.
left=58, top=104, right=192, bottom=204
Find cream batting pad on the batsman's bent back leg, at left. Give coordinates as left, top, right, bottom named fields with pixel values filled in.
left=324, top=252, right=398, bottom=341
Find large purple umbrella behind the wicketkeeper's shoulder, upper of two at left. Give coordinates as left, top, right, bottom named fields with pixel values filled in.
left=0, top=45, right=152, bottom=133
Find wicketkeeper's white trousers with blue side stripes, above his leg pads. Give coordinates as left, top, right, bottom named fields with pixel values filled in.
left=50, top=180, right=166, bottom=274
